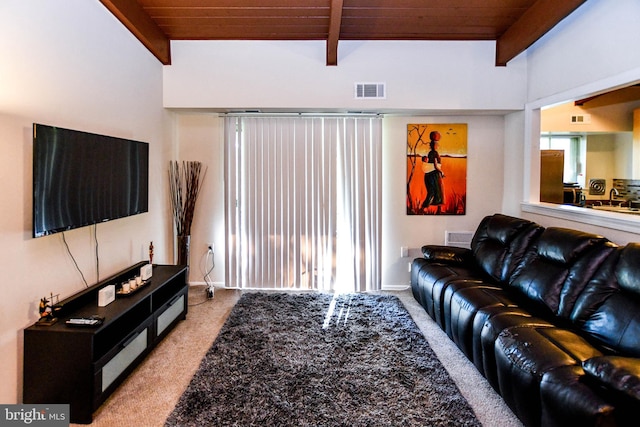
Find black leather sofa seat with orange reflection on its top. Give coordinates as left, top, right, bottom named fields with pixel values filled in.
left=495, top=326, right=602, bottom=425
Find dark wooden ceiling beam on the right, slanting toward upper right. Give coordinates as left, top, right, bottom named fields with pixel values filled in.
left=496, top=0, right=586, bottom=66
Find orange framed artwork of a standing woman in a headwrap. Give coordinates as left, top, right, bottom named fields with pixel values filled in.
left=406, top=123, right=467, bottom=215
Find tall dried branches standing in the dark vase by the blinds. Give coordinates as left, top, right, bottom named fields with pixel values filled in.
left=169, top=161, right=207, bottom=236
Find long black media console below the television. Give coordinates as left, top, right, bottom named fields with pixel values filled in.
left=23, top=262, right=188, bottom=424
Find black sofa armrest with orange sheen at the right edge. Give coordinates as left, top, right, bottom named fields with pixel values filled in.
left=582, top=356, right=640, bottom=402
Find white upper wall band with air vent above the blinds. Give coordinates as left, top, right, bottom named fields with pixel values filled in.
left=164, top=41, right=526, bottom=113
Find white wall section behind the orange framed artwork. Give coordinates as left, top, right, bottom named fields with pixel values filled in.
left=381, top=115, right=505, bottom=288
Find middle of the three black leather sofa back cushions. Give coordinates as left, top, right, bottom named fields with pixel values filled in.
left=509, top=227, right=616, bottom=321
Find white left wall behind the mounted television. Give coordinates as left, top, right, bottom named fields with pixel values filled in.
left=0, top=0, right=171, bottom=403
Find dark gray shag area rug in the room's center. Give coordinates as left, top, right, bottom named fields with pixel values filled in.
left=166, top=293, right=481, bottom=427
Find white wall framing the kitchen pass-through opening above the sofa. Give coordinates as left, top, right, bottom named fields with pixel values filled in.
left=516, top=0, right=640, bottom=244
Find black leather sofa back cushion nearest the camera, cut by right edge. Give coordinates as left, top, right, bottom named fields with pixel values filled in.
left=571, top=243, right=640, bottom=357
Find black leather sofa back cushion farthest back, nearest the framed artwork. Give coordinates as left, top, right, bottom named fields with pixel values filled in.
left=471, top=214, right=543, bottom=285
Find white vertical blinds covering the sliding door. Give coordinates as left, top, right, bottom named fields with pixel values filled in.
left=225, top=116, right=382, bottom=292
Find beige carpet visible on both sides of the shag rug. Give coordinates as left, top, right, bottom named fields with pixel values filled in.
left=72, top=287, right=521, bottom=427
